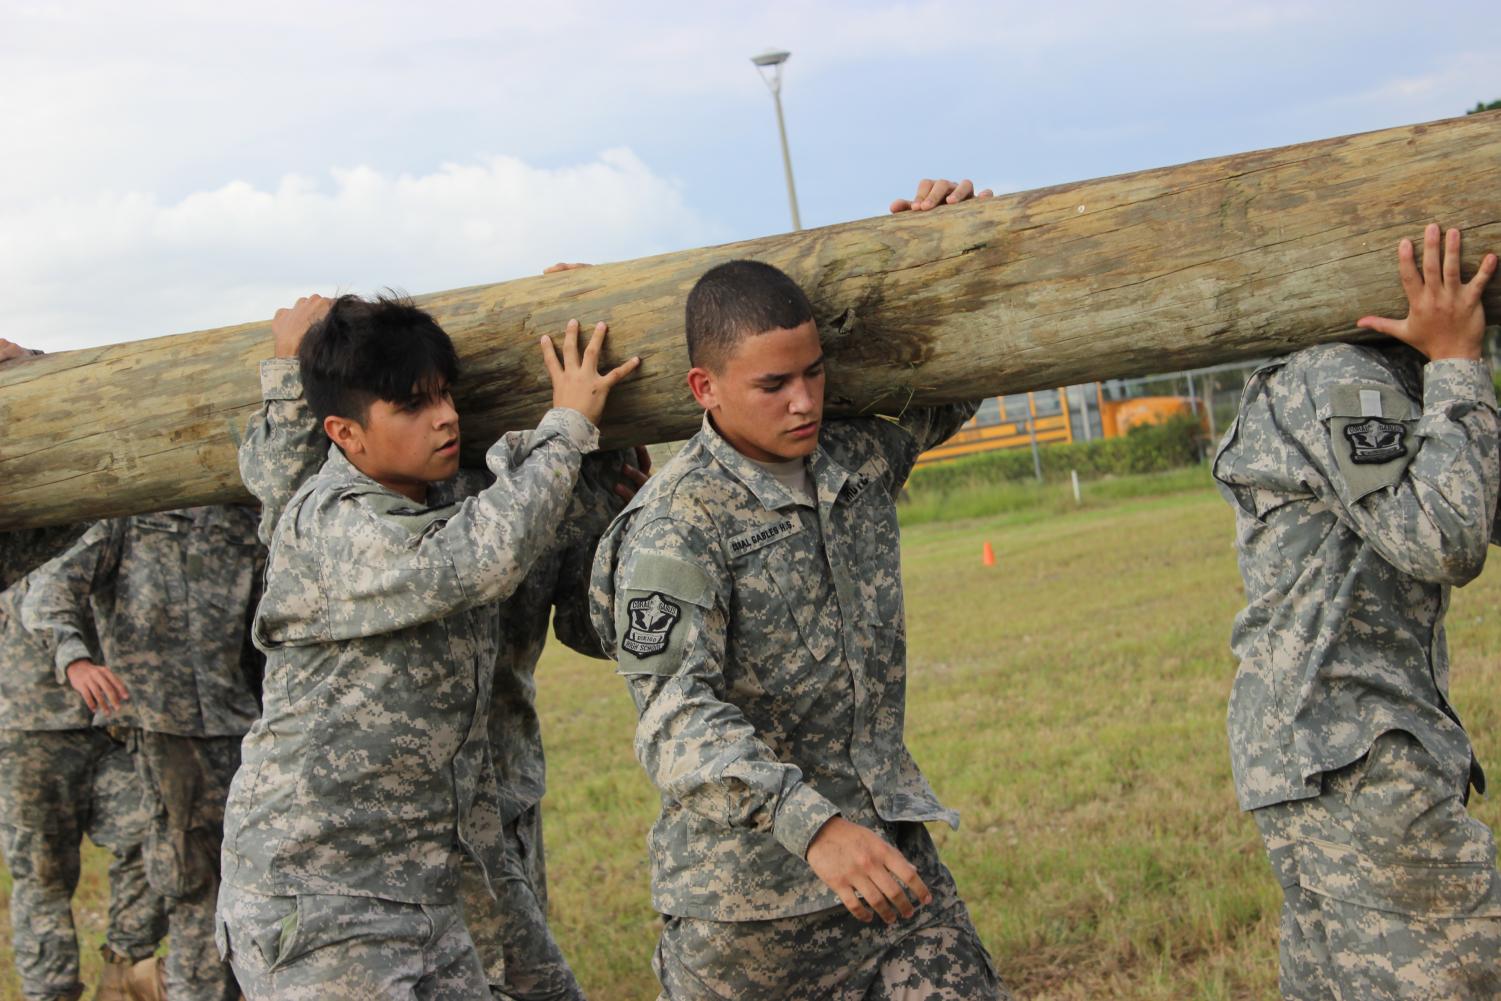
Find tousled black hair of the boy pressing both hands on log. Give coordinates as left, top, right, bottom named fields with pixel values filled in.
left=297, top=293, right=459, bottom=423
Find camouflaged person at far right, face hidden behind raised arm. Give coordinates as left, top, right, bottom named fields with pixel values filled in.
left=1214, top=225, right=1501, bottom=1001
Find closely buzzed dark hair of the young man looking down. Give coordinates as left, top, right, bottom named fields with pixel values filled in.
left=684, top=261, right=814, bottom=369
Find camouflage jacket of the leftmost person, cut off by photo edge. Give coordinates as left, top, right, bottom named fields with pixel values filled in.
left=0, top=578, right=98, bottom=729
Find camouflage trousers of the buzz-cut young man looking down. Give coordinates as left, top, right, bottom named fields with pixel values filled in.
left=651, top=824, right=1010, bottom=1001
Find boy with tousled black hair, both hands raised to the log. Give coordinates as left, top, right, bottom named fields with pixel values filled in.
left=219, top=296, right=638, bottom=999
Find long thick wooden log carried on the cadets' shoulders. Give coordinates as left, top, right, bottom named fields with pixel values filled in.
left=0, top=113, right=1501, bottom=528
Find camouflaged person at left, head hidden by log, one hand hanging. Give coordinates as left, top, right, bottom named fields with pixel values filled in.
left=21, top=506, right=266, bottom=1001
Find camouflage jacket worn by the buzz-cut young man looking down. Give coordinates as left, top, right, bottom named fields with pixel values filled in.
left=591, top=405, right=974, bottom=921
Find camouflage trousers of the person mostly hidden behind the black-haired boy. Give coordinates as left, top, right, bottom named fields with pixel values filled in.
left=464, top=806, right=584, bottom=1001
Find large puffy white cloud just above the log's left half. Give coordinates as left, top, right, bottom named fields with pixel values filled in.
left=0, top=149, right=723, bottom=351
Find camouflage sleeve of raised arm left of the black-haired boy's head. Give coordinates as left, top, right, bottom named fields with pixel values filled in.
left=239, top=359, right=329, bottom=545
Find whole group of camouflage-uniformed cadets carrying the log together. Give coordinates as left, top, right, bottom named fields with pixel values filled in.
left=0, top=182, right=1501, bottom=1001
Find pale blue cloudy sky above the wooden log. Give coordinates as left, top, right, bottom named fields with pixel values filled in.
left=0, top=0, right=1501, bottom=350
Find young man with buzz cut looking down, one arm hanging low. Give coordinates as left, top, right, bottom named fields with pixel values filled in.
left=593, top=177, right=1007, bottom=1001
